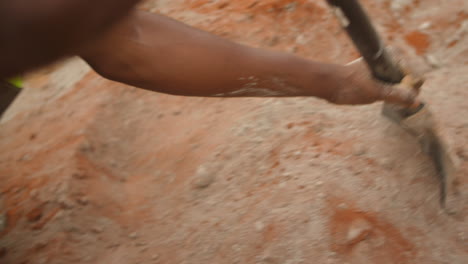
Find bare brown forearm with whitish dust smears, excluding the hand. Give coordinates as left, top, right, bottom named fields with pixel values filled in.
left=82, top=12, right=335, bottom=98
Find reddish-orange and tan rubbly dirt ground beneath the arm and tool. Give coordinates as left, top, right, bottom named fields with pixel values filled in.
left=0, top=0, right=468, bottom=264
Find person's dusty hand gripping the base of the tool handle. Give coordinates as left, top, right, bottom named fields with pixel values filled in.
left=329, top=59, right=422, bottom=107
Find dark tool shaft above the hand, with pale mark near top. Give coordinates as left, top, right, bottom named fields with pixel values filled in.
left=327, top=0, right=405, bottom=83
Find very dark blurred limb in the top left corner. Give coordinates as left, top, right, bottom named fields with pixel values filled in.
left=0, top=0, right=139, bottom=78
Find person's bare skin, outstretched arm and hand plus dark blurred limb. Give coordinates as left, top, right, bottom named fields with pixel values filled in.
left=0, top=0, right=415, bottom=105
